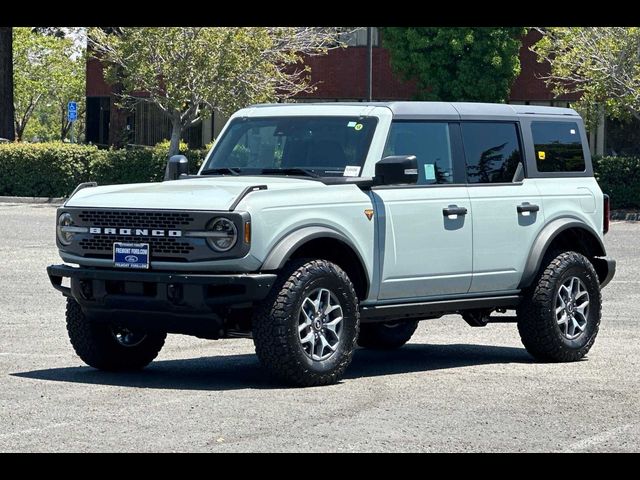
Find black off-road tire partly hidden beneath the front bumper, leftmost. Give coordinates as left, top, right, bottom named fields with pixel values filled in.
left=67, top=298, right=167, bottom=371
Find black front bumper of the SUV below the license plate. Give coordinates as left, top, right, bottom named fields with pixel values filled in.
left=47, top=265, right=277, bottom=330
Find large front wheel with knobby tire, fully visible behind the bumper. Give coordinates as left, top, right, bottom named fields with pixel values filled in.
left=253, top=260, right=360, bottom=386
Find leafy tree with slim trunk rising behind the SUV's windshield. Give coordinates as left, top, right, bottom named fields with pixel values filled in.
left=88, top=27, right=340, bottom=155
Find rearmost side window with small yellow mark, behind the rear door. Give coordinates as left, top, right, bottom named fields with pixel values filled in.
left=531, top=122, right=585, bottom=172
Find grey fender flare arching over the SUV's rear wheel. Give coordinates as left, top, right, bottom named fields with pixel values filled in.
left=518, top=218, right=606, bottom=289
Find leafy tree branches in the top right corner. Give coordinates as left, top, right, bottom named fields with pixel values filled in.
left=531, top=27, right=640, bottom=124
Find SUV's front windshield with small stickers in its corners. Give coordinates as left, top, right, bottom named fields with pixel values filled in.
left=201, top=117, right=377, bottom=176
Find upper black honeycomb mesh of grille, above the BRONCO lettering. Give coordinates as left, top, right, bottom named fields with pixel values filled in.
left=78, top=210, right=194, bottom=230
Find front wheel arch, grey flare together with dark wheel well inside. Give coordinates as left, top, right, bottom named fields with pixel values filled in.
left=261, top=226, right=371, bottom=300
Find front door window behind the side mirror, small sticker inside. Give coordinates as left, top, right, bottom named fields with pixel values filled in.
left=384, top=121, right=453, bottom=185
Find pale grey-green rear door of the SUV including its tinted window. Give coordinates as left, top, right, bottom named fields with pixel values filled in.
left=461, top=121, right=544, bottom=293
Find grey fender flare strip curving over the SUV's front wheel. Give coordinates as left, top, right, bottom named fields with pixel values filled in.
left=260, top=226, right=370, bottom=283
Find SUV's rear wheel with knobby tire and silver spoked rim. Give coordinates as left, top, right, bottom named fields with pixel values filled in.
left=517, top=252, right=601, bottom=362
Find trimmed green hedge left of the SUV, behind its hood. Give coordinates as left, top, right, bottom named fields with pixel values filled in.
left=0, top=142, right=206, bottom=197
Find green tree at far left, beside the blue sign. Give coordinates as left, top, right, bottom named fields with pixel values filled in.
left=13, top=27, right=85, bottom=140
